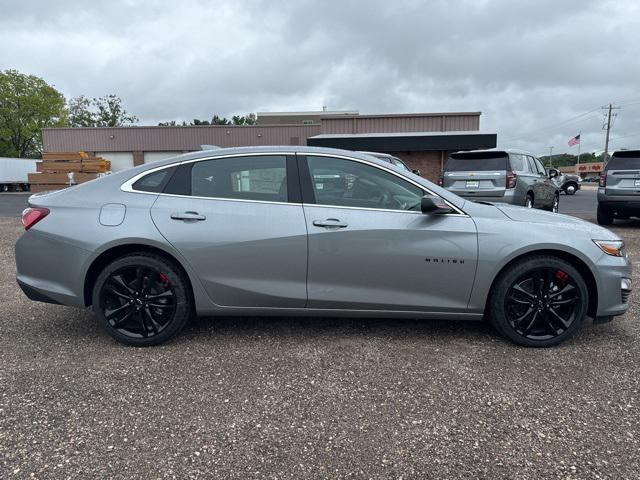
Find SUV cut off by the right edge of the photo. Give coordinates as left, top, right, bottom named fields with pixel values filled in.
left=598, top=150, right=640, bottom=225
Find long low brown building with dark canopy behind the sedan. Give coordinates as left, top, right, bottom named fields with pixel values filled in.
left=43, top=111, right=497, bottom=180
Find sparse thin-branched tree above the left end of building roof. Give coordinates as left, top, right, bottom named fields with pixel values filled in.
left=69, top=94, right=138, bottom=127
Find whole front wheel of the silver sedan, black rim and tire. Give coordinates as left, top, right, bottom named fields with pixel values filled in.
left=488, top=255, right=589, bottom=347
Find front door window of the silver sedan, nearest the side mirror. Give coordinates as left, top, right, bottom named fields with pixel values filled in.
left=307, top=156, right=424, bottom=211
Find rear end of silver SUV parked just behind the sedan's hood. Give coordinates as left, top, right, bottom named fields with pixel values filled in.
left=442, top=152, right=509, bottom=197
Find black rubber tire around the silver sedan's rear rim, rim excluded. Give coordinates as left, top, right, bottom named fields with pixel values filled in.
left=92, top=254, right=192, bottom=346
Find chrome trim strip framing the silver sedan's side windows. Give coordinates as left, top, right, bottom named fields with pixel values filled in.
left=120, top=152, right=468, bottom=216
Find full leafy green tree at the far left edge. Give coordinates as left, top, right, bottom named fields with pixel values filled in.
left=0, top=70, right=66, bottom=157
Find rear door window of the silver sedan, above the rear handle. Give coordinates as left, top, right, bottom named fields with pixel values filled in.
left=191, top=155, right=288, bottom=202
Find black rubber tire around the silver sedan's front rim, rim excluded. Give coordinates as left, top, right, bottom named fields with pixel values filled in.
left=489, top=256, right=589, bottom=347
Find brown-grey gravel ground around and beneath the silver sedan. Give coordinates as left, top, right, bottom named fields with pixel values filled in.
left=0, top=218, right=640, bottom=479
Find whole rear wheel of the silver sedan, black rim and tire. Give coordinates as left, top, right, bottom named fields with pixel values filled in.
left=92, top=252, right=193, bottom=347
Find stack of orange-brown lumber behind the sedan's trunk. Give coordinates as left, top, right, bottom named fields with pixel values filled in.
left=29, top=152, right=111, bottom=192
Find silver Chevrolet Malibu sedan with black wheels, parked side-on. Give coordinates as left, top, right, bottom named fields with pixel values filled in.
left=16, top=147, right=631, bottom=347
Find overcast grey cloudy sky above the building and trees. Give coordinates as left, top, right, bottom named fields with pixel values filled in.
left=0, top=0, right=640, bottom=154
